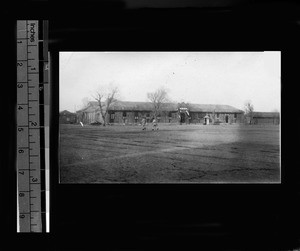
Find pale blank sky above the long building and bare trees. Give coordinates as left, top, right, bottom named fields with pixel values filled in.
left=59, top=52, right=281, bottom=112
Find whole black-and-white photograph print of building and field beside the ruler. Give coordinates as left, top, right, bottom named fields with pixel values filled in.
left=59, top=51, right=281, bottom=184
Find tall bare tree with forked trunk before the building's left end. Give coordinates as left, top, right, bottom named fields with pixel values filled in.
left=92, top=85, right=119, bottom=126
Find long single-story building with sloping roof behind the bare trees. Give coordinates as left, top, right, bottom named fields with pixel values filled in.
left=76, top=101, right=244, bottom=124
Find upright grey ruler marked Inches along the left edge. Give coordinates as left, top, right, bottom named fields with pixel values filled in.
left=16, top=20, right=49, bottom=232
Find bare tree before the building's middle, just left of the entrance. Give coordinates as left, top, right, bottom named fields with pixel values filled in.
left=147, top=87, right=169, bottom=119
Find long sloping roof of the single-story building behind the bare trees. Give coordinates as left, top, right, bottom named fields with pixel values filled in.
left=77, top=101, right=243, bottom=113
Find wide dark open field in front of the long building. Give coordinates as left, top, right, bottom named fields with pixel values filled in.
left=60, top=124, right=280, bottom=183
